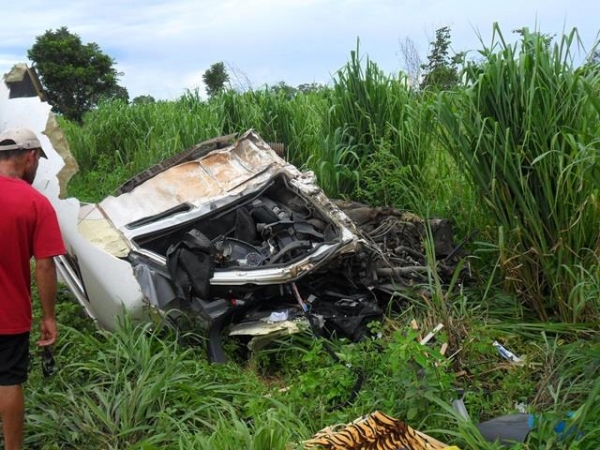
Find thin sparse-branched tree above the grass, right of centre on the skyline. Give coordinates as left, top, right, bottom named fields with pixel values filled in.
left=421, top=27, right=465, bottom=90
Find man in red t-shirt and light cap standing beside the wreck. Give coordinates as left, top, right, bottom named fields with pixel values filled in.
left=0, top=128, right=65, bottom=450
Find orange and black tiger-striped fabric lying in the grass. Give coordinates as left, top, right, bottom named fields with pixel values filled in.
left=303, top=411, right=458, bottom=450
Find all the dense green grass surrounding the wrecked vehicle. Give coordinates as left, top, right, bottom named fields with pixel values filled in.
left=16, top=25, right=600, bottom=449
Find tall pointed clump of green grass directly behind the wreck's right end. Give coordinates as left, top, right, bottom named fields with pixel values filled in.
left=324, top=46, right=435, bottom=206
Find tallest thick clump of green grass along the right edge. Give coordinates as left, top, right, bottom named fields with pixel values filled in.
left=439, top=27, right=600, bottom=322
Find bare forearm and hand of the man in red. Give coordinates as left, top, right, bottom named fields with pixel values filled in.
left=35, top=258, right=58, bottom=346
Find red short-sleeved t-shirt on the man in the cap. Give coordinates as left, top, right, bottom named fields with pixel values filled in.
left=0, top=176, right=66, bottom=334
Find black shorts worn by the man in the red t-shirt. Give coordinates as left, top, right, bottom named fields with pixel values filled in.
left=0, top=333, right=29, bottom=386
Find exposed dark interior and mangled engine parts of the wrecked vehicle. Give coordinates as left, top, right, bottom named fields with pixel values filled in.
left=134, top=176, right=389, bottom=360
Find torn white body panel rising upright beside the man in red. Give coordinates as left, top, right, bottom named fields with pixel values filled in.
left=0, top=67, right=143, bottom=328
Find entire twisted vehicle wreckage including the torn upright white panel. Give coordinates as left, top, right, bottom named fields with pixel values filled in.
left=0, top=65, right=468, bottom=361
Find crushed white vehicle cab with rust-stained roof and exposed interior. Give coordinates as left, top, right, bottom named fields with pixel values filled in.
left=70, top=132, right=392, bottom=359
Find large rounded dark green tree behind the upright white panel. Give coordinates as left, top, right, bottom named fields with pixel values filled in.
left=27, top=27, right=129, bottom=122
